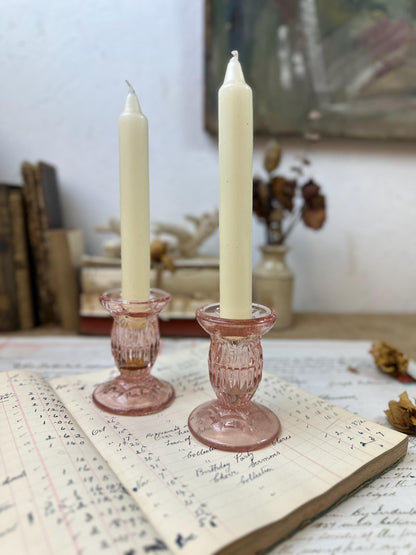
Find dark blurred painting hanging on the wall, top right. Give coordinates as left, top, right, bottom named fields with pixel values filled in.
left=205, top=0, right=416, bottom=139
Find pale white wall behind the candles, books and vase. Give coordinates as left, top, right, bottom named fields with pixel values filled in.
left=0, top=0, right=416, bottom=312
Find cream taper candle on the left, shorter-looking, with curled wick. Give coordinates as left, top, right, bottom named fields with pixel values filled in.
left=118, top=83, right=150, bottom=301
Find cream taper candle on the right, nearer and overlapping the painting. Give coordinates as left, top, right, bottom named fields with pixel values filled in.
left=218, top=51, right=253, bottom=319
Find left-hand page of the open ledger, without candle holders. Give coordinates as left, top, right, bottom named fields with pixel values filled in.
left=0, top=372, right=168, bottom=555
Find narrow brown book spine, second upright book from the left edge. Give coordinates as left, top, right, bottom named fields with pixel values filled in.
left=9, top=188, right=35, bottom=330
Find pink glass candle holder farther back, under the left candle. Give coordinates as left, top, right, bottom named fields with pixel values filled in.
left=92, top=289, right=175, bottom=416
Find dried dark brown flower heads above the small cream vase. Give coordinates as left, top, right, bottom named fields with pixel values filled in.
left=253, top=141, right=326, bottom=245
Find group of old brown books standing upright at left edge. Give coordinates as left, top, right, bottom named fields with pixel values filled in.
left=0, top=162, right=83, bottom=331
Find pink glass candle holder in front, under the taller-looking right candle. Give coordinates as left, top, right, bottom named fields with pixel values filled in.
left=188, top=304, right=281, bottom=451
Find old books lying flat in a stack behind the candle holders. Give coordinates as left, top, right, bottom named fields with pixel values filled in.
left=80, top=255, right=219, bottom=336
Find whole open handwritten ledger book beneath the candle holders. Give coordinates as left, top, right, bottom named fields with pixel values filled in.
left=0, top=345, right=407, bottom=555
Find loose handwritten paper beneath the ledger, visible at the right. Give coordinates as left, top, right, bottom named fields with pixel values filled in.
left=260, top=340, right=416, bottom=555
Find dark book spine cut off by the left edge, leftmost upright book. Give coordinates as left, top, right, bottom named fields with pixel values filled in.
left=0, top=185, right=19, bottom=331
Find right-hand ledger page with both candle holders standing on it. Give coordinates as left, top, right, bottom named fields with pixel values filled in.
left=53, top=344, right=404, bottom=554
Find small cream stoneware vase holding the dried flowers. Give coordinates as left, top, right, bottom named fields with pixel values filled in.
left=253, top=245, right=294, bottom=329
